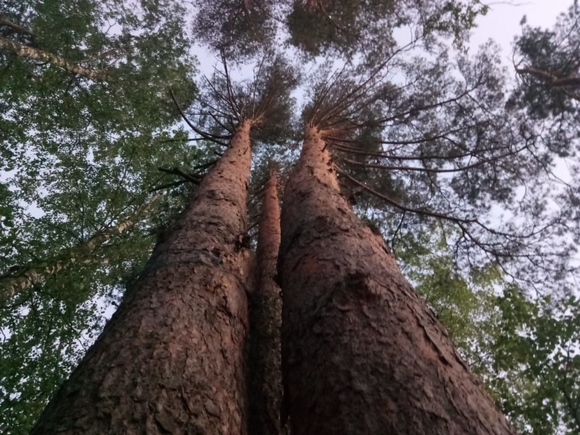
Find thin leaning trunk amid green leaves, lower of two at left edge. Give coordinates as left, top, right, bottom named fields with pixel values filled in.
left=0, top=194, right=161, bottom=304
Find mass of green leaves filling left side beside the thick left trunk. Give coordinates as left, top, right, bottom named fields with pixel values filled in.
left=0, top=0, right=210, bottom=434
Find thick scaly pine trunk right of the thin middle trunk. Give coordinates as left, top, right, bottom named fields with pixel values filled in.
left=279, top=123, right=515, bottom=435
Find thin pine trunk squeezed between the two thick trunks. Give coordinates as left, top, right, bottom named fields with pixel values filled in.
left=249, top=165, right=283, bottom=435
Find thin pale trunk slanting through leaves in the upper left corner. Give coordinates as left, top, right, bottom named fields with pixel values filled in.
left=0, top=36, right=107, bottom=82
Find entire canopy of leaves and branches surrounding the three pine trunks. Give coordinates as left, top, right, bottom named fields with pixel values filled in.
left=0, top=0, right=580, bottom=434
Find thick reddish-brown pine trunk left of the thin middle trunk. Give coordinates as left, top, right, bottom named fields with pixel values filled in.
left=32, top=122, right=251, bottom=435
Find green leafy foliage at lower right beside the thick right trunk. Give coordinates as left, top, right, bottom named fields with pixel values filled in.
left=396, top=227, right=580, bottom=435
